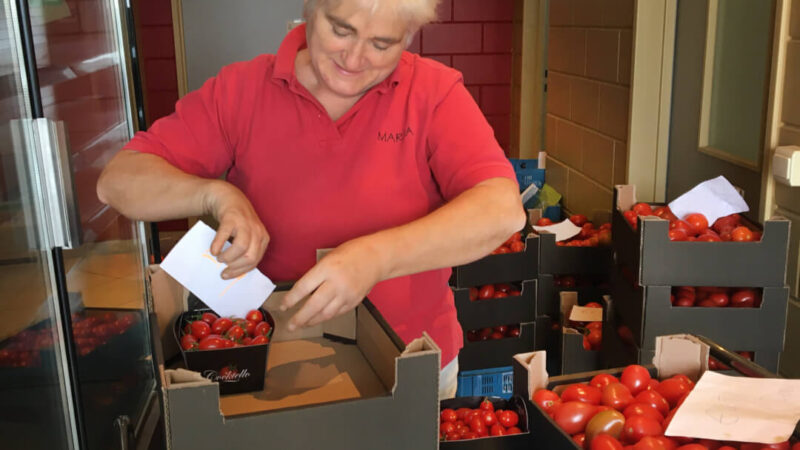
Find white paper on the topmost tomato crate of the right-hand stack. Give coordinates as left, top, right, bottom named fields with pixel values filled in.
left=669, top=175, right=750, bottom=226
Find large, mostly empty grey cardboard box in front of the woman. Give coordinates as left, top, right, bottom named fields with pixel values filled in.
left=149, top=267, right=440, bottom=450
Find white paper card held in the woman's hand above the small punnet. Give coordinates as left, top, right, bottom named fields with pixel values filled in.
left=161, top=221, right=275, bottom=317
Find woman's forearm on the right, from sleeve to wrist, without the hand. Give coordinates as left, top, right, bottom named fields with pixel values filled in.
left=363, top=178, right=525, bottom=279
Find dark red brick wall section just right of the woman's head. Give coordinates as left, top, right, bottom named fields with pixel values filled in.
left=409, top=0, right=514, bottom=154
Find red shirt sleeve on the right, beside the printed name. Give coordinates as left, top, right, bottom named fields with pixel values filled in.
left=428, top=79, right=516, bottom=200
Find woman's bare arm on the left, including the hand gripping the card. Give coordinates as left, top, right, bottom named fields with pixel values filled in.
left=97, top=150, right=269, bottom=278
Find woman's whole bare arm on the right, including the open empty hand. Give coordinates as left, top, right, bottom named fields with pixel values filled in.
left=282, top=178, right=525, bottom=328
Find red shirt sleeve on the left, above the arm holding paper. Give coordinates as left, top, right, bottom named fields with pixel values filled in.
left=125, top=60, right=245, bottom=178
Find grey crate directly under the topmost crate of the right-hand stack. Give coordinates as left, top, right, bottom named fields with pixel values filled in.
left=611, top=266, right=789, bottom=351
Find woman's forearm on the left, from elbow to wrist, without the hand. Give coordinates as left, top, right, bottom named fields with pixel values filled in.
left=97, top=150, right=227, bottom=222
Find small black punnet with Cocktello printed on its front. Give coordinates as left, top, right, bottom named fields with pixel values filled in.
left=172, top=308, right=275, bottom=395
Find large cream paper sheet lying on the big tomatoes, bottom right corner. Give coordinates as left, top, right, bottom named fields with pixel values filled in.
left=665, top=371, right=800, bottom=444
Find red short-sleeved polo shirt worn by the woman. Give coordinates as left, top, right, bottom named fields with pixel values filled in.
left=126, top=26, right=515, bottom=365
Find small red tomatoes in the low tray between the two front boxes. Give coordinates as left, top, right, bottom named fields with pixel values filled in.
left=439, top=399, right=522, bottom=441
